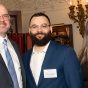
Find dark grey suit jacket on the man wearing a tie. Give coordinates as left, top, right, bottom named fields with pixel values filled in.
left=0, top=40, right=26, bottom=88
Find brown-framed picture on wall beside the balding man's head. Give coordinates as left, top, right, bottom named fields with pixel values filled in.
left=9, top=11, right=22, bottom=33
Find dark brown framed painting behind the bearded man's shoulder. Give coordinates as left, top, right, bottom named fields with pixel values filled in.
left=51, top=24, right=73, bottom=47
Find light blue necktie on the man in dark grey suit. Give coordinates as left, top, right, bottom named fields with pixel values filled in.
left=3, top=39, right=19, bottom=88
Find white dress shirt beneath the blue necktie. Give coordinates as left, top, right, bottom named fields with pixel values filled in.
left=0, top=36, right=23, bottom=88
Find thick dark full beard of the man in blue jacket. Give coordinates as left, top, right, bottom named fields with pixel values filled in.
left=30, top=31, right=51, bottom=46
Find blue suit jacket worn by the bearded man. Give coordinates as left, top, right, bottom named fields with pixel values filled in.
left=22, top=41, right=83, bottom=88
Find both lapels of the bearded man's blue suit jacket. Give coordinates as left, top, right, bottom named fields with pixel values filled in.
left=26, top=43, right=54, bottom=88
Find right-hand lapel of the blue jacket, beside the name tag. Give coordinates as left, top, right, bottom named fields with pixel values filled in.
left=38, top=41, right=55, bottom=86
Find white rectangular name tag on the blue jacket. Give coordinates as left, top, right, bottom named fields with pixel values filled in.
left=44, top=69, right=57, bottom=78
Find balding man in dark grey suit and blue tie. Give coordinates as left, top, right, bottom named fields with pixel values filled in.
left=0, top=4, right=26, bottom=88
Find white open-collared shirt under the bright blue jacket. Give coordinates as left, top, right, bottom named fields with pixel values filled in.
left=30, top=43, right=49, bottom=85
